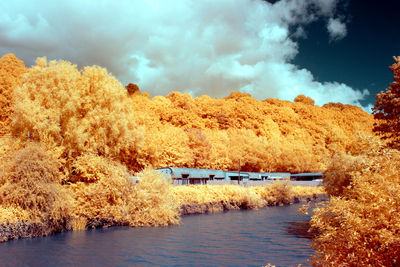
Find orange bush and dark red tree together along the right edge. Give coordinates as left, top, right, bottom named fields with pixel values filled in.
left=311, top=57, right=400, bottom=266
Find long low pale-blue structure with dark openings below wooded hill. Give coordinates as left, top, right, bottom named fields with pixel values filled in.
left=156, top=167, right=291, bottom=185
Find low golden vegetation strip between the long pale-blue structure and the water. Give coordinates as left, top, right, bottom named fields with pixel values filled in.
left=172, top=182, right=328, bottom=215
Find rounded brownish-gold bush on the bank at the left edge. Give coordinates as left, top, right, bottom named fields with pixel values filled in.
left=0, top=144, right=72, bottom=223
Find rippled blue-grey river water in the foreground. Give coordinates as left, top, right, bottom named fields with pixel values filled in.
left=0, top=204, right=313, bottom=266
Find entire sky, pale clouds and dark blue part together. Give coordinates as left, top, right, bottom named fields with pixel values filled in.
left=0, top=0, right=400, bottom=111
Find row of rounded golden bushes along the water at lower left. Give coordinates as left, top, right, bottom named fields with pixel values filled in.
left=0, top=143, right=179, bottom=239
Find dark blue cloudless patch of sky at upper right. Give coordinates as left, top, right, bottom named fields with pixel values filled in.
left=294, top=0, right=400, bottom=109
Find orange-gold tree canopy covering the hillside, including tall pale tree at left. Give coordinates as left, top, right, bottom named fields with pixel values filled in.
left=0, top=55, right=373, bottom=176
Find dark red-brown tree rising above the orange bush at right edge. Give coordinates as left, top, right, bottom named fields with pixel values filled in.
left=372, top=57, right=400, bottom=149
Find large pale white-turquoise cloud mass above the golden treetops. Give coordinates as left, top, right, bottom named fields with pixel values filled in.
left=0, top=0, right=368, bottom=109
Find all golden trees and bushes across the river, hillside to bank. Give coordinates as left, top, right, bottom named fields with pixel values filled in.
left=0, top=55, right=373, bottom=244
